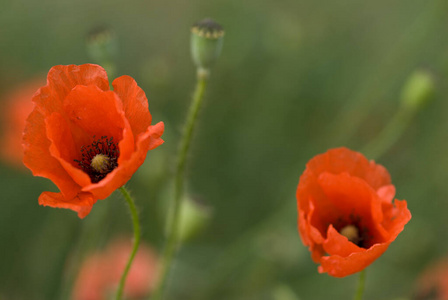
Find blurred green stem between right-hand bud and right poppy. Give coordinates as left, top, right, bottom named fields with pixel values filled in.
left=361, top=106, right=415, bottom=159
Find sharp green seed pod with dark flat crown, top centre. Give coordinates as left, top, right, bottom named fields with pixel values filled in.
left=191, top=19, right=224, bottom=73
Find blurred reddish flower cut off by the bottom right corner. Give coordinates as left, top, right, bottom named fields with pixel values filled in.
left=413, top=258, right=448, bottom=300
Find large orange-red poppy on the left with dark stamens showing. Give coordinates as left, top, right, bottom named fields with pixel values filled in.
left=23, top=64, right=164, bottom=218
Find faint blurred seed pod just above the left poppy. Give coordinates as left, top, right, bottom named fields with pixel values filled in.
left=86, top=26, right=118, bottom=77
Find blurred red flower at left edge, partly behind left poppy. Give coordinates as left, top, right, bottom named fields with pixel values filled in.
left=0, top=79, right=45, bottom=168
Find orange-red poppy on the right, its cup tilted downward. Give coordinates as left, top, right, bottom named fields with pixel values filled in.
left=296, top=148, right=411, bottom=277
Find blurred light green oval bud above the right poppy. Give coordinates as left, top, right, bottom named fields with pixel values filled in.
left=401, top=70, right=434, bottom=110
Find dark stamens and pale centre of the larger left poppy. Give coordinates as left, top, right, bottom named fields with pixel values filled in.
left=75, top=136, right=120, bottom=183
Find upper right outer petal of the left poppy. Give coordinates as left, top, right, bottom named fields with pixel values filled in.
left=112, top=76, right=152, bottom=136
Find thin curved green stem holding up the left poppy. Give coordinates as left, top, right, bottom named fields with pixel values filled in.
left=115, top=186, right=140, bottom=300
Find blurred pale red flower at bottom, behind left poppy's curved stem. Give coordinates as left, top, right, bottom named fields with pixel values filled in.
left=73, top=239, right=157, bottom=300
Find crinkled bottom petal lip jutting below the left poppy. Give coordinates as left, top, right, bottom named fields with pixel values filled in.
left=39, top=192, right=96, bottom=219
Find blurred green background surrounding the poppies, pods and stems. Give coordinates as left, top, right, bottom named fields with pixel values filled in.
left=0, top=0, right=448, bottom=300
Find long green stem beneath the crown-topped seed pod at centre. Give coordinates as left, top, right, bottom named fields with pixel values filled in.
left=153, top=70, right=209, bottom=300
